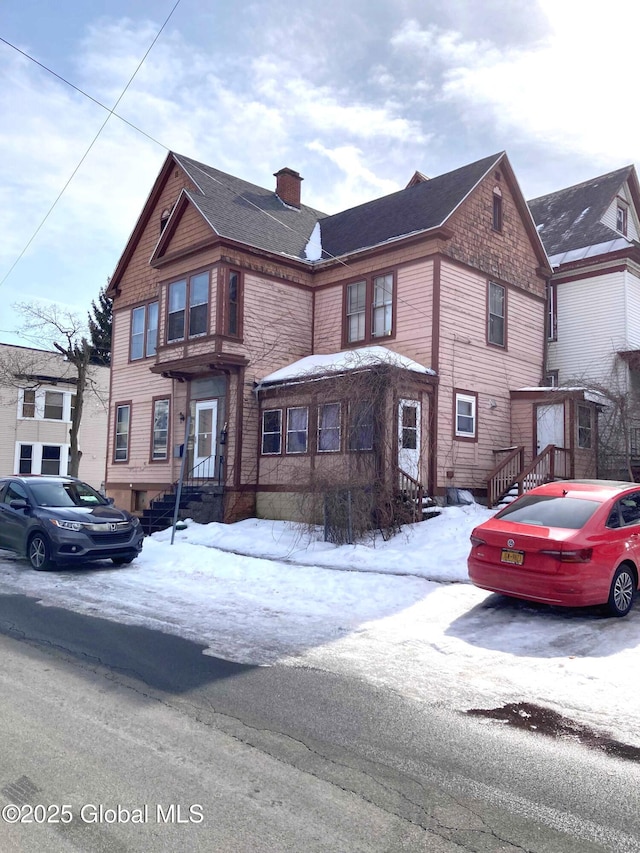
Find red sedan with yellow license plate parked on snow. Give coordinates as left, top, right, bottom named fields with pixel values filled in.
left=467, top=480, right=640, bottom=616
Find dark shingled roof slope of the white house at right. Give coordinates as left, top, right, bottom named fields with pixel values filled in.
left=529, top=166, right=640, bottom=257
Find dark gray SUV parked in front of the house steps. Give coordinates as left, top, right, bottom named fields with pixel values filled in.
left=0, top=476, right=144, bottom=570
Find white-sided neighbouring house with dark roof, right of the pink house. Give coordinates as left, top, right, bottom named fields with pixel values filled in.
left=529, top=166, right=640, bottom=479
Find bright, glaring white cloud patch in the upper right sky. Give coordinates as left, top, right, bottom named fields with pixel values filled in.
left=392, top=0, right=640, bottom=169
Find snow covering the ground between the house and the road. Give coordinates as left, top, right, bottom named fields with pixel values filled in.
left=0, top=505, right=640, bottom=745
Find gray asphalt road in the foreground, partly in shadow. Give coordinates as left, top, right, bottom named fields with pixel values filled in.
left=0, top=596, right=640, bottom=853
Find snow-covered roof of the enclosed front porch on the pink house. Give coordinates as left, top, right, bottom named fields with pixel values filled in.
left=257, top=346, right=435, bottom=391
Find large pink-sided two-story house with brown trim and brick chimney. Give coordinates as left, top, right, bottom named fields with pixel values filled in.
left=107, top=153, right=593, bottom=520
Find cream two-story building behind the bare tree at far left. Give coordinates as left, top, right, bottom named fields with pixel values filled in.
left=0, top=344, right=109, bottom=488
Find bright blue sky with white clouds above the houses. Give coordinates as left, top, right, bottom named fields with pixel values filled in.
left=0, top=0, right=640, bottom=343
